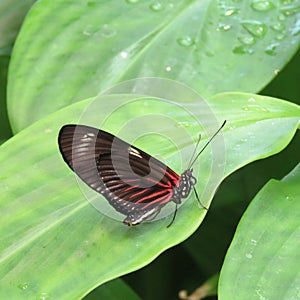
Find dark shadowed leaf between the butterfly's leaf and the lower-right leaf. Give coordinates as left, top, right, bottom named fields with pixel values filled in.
left=182, top=132, right=300, bottom=278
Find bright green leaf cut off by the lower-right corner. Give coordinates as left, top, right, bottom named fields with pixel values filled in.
left=219, top=164, right=300, bottom=299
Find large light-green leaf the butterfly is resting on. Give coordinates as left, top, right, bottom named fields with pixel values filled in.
left=0, top=93, right=299, bottom=299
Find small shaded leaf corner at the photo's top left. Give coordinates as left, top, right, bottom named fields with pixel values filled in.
left=0, top=0, right=34, bottom=54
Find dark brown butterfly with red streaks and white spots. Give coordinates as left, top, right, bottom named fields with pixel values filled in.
left=58, top=121, right=226, bottom=227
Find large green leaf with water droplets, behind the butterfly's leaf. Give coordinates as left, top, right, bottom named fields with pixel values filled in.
left=8, top=0, right=300, bottom=131
